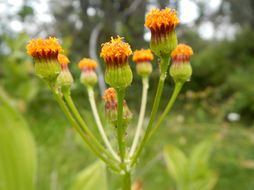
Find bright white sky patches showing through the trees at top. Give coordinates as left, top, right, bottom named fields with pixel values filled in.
left=0, top=0, right=234, bottom=40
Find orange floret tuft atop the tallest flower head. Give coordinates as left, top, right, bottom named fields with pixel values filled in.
left=145, top=8, right=179, bottom=31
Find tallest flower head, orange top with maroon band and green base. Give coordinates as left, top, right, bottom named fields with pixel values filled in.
left=145, top=8, right=179, bottom=57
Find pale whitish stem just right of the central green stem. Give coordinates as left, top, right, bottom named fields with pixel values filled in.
left=129, top=77, right=149, bottom=158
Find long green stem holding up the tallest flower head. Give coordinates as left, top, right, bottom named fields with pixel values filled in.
left=131, top=57, right=169, bottom=166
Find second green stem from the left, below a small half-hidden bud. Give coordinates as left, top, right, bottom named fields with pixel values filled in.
left=63, top=93, right=118, bottom=162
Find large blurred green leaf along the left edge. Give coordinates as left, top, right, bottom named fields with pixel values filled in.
left=0, top=88, right=37, bottom=190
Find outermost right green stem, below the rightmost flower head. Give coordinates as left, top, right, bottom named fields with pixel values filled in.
left=149, top=82, right=183, bottom=137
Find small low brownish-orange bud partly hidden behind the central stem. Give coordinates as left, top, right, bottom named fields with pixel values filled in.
left=103, top=88, right=132, bottom=125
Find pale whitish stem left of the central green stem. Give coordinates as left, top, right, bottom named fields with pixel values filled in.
left=87, top=87, right=120, bottom=162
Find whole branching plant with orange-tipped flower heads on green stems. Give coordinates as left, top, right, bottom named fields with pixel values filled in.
left=27, top=8, right=193, bottom=190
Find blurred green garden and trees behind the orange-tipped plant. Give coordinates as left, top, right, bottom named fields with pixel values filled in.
left=0, top=0, right=254, bottom=190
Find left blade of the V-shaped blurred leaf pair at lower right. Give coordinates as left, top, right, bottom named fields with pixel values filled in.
left=164, top=145, right=187, bottom=183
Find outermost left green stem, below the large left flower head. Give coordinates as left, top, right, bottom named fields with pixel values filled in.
left=50, top=88, right=120, bottom=172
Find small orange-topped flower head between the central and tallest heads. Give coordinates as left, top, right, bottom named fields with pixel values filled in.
left=132, top=49, right=153, bottom=77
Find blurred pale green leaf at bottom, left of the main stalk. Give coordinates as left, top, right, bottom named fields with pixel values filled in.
left=70, top=161, right=108, bottom=190
